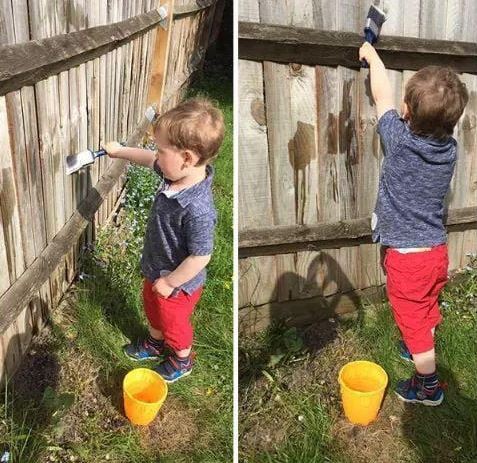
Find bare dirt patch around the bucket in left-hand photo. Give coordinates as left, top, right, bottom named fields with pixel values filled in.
left=4, top=300, right=205, bottom=463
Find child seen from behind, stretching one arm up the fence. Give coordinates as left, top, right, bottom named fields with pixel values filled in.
left=359, top=43, right=468, bottom=405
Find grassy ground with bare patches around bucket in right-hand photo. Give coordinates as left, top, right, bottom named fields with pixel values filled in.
left=239, top=259, right=477, bottom=463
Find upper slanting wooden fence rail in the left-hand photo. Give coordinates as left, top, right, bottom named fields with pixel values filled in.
left=0, top=10, right=162, bottom=96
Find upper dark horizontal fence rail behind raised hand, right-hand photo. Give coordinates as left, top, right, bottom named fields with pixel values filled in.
left=238, top=21, right=477, bottom=74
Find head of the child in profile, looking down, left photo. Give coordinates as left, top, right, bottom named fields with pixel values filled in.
left=154, top=98, right=224, bottom=180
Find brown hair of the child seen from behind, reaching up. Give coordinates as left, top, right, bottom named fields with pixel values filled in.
left=404, top=66, right=469, bottom=139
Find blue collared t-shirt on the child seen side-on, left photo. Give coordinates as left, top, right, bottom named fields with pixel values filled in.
left=141, top=163, right=217, bottom=294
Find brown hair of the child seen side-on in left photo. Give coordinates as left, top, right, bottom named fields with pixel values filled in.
left=154, top=97, right=224, bottom=165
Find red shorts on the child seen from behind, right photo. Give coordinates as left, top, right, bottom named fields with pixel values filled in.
left=384, top=244, right=449, bottom=354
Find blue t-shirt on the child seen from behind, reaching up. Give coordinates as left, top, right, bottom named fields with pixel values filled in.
left=372, top=109, right=457, bottom=248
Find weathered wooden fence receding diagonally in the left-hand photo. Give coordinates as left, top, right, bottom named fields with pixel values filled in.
left=0, top=0, right=220, bottom=378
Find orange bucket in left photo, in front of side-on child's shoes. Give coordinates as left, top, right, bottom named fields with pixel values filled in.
left=123, top=368, right=167, bottom=426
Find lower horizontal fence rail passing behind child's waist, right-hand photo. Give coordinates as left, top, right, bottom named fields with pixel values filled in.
left=239, top=206, right=477, bottom=258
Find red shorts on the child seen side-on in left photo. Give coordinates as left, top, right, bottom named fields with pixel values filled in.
left=142, top=279, right=202, bottom=351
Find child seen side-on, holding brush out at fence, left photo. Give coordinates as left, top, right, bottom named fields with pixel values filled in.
left=104, top=98, right=224, bottom=382
